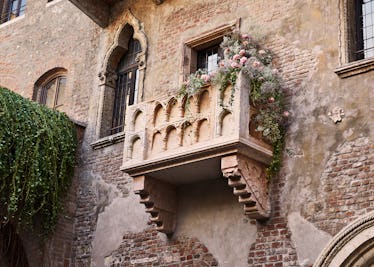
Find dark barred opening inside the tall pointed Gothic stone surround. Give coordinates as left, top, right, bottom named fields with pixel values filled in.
left=110, top=38, right=141, bottom=134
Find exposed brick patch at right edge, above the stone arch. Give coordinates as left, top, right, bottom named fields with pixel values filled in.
left=302, top=137, right=374, bottom=235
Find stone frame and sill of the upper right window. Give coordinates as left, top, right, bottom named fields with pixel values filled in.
left=334, top=0, right=374, bottom=78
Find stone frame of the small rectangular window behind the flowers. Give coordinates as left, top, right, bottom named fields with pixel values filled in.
left=180, top=19, right=240, bottom=83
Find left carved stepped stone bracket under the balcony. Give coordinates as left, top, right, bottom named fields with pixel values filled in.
left=134, top=175, right=177, bottom=234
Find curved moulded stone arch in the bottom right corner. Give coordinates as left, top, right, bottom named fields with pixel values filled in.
left=314, top=211, right=374, bottom=267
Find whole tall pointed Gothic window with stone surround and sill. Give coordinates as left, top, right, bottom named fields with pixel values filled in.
left=92, top=10, right=147, bottom=143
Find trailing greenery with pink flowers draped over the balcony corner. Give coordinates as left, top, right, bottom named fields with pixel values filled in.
left=179, top=32, right=290, bottom=177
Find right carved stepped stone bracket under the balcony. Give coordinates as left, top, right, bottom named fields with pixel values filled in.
left=221, top=154, right=270, bottom=219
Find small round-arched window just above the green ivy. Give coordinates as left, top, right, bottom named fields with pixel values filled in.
left=33, top=68, right=66, bottom=109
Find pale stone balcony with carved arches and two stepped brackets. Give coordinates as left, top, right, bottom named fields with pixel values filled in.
left=122, top=76, right=272, bottom=233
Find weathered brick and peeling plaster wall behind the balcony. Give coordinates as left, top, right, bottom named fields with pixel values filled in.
left=0, top=0, right=374, bottom=266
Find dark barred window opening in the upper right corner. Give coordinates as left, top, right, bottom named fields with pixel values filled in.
left=349, top=0, right=374, bottom=61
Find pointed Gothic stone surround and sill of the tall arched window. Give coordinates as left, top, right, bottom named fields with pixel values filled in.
left=91, top=10, right=148, bottom=149
